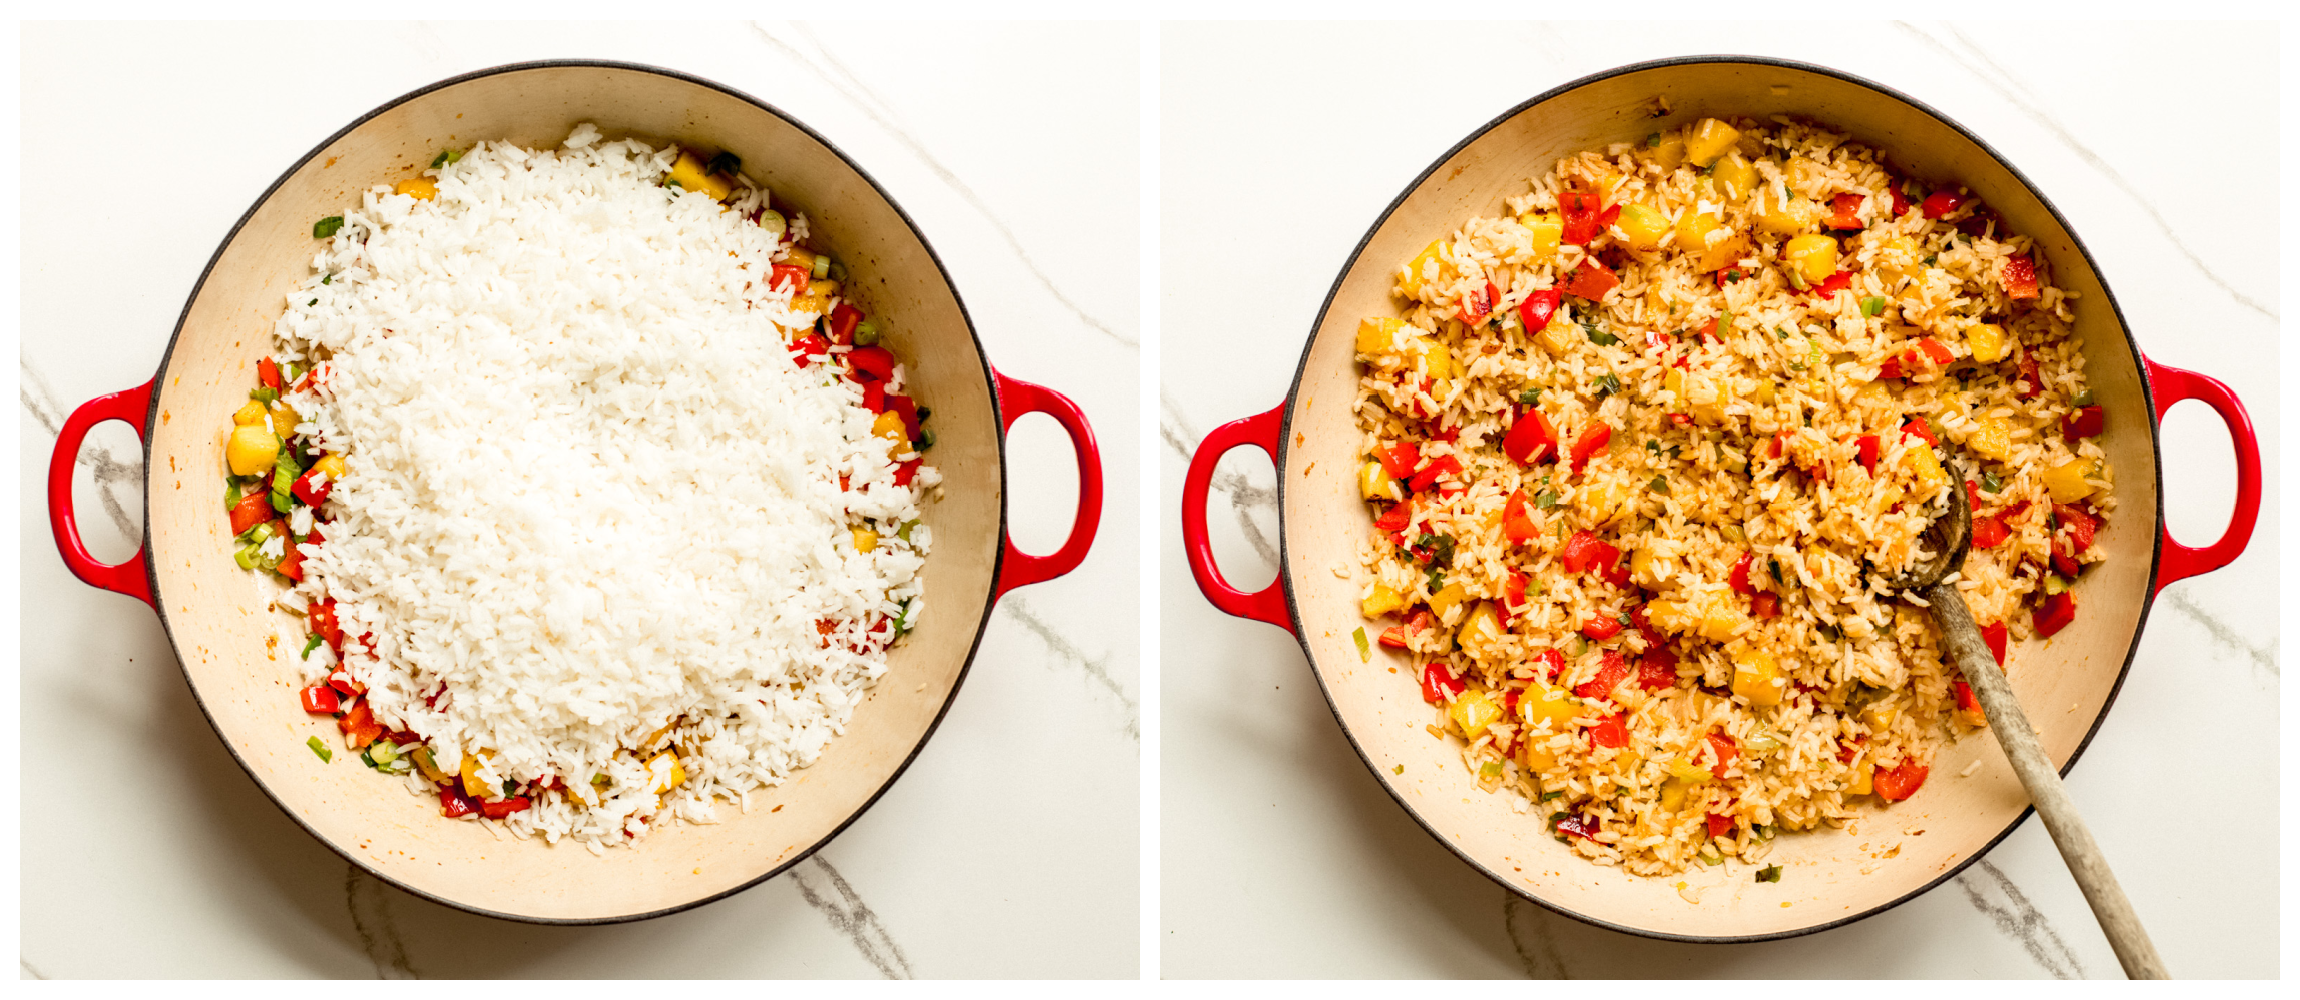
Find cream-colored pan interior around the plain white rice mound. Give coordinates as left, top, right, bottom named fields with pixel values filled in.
left=147, top=64, right=1001, bottom=920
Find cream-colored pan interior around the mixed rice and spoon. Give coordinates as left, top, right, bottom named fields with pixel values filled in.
left=1281, top=62, right=2157, bottom=938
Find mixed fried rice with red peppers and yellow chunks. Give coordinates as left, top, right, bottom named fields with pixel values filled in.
left=1357, top=120, right=2114, bottom=874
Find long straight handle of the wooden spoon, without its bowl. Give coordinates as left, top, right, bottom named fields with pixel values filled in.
left=1925, top=584, right=2171, bottom=979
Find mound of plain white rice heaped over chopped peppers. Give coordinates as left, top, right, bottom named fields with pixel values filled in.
left=278, top=124, right=936, bottom=846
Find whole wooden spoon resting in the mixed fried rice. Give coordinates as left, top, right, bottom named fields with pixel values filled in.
left=1888, top=448, right=2171, bottom=979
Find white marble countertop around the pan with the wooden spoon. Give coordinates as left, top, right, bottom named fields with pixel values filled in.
left=1159, top=23, right=2279, bottom=977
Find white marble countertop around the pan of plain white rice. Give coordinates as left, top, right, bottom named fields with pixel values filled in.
left=18, top=23, right=1141, bottom=977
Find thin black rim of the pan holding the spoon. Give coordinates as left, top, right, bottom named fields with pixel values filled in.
left=1277, top=55, right=2164, bottom=945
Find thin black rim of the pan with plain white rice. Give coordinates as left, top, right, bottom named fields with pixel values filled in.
left=140, top=60, right=1007, bottom=926
